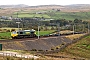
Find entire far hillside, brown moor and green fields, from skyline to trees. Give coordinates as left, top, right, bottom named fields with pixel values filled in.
left=0, top=4, right=90, bottom=20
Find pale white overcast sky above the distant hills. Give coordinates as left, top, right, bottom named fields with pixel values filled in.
left=0, top=0, right=90, bottom=6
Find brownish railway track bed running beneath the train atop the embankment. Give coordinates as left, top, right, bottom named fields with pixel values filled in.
left=0, top=33, right=86, bottom=42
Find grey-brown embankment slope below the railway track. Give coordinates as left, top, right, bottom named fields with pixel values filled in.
left=0, top=32, right=87, bottom=54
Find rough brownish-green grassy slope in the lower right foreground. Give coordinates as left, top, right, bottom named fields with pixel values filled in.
left=52, top=35, right=90, bottom=60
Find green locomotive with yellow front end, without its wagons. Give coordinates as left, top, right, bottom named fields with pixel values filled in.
left=11, top=29, right=37, bottom=39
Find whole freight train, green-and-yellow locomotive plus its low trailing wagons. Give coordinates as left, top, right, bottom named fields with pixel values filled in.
left=11, top=29, right=82, bottom=39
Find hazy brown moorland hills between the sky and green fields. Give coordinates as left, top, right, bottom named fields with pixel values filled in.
left=0, top=4, right=90, bottom=16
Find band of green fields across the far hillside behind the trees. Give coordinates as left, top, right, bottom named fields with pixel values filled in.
left=13, top=10, right=90, bottom=20
